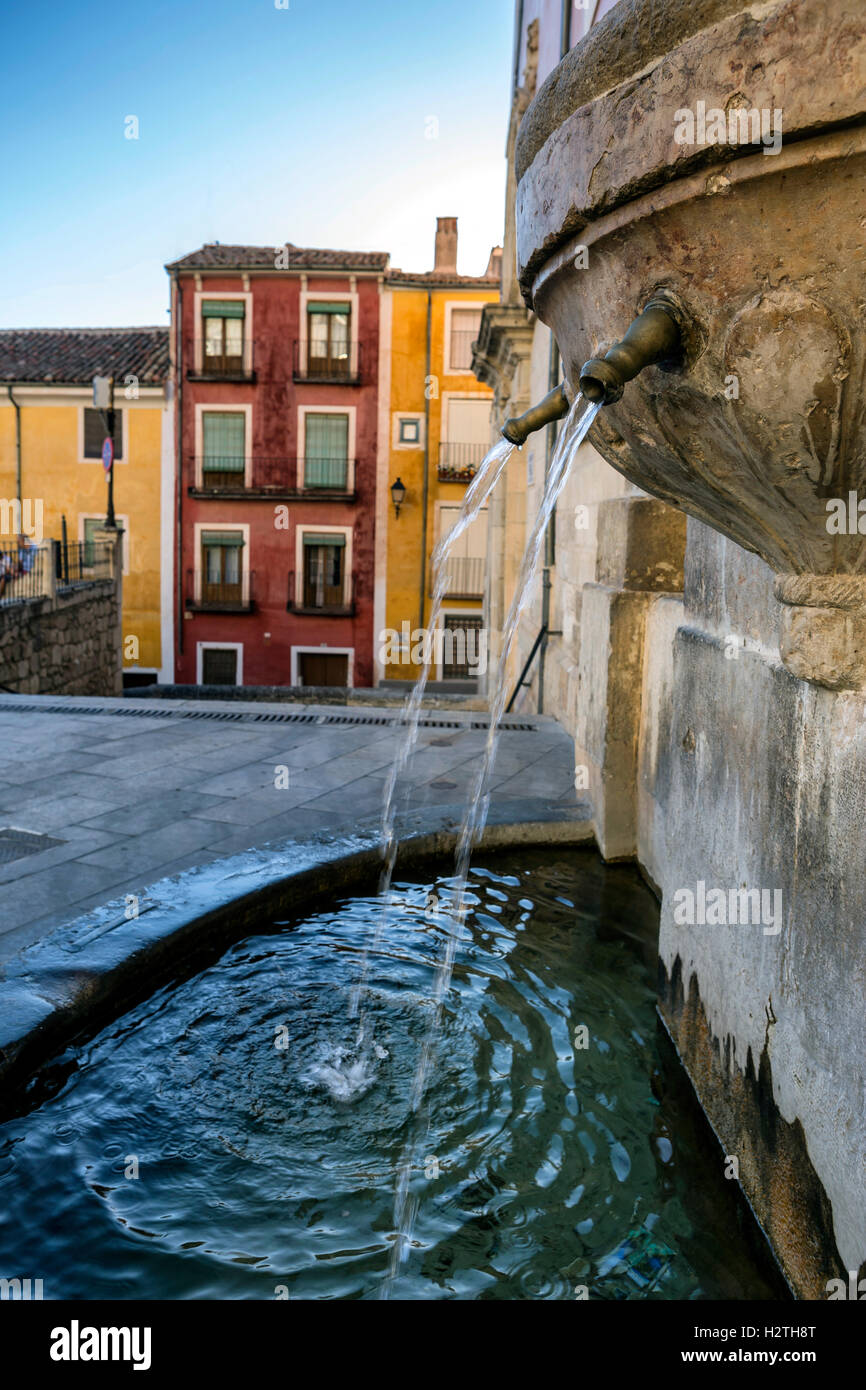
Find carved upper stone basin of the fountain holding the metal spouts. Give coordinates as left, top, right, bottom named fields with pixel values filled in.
left=517, top=0, right=866, bottom=688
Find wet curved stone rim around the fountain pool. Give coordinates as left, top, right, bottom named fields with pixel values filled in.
left=0, top=798, right=595, bottom=1113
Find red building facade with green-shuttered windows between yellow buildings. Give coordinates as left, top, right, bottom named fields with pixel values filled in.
left=167, top=243, right=388, bottom=685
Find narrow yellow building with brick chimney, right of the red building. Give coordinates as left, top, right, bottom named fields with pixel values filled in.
left=379, top=218, right=499, bottom=682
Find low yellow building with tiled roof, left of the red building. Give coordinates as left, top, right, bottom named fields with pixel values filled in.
left=0, top=328, right=174, bottom=685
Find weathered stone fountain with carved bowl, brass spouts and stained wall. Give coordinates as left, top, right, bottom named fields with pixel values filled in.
left=505, top=0, right=866, bottom=1298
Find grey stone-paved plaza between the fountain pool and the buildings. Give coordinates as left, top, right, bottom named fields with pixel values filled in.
left=0, top=695, right=577, bottom=960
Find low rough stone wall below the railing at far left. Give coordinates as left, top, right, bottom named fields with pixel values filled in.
left=0, top=580, right=124, bottom=695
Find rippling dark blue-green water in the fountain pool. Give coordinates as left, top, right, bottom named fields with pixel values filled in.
left=0, top=852, right=774, bottom=1298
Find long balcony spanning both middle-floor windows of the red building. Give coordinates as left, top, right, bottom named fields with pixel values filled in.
left=188, top=455, right=357, bottom=502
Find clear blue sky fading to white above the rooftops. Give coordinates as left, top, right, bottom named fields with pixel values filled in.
left=0, top=0, right=513, bottom=328
